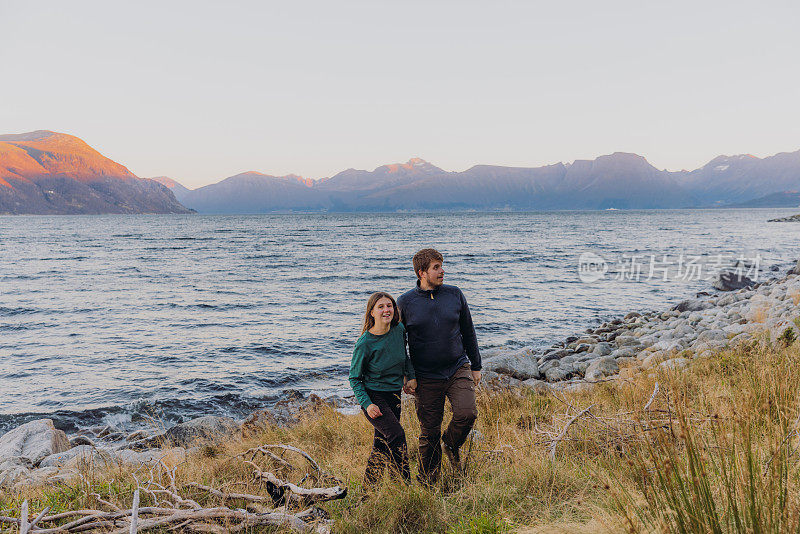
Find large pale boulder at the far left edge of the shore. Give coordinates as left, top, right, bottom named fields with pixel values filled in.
left=0, top=419, right=70, bottom=467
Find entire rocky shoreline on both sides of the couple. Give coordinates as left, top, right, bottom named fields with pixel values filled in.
left=6, top=261, right=800, bottom=488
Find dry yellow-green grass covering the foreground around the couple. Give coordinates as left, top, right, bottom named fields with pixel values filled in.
left=0, top=343, right=800, bottom=533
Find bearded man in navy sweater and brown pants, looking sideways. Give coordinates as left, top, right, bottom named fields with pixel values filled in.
left=397, top=248, right=481, bottom=484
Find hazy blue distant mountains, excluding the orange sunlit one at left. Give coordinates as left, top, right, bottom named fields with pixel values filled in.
left=154, top=151, right=800, bottom=213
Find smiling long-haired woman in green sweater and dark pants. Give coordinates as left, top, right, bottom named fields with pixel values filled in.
left=350, top=292, right=417, bottom=486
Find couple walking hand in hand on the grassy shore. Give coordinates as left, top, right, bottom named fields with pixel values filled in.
left=350, top=248, right=481, bottom=485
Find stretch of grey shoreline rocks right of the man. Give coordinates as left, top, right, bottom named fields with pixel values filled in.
left=483, top=261, right=800, bottom=390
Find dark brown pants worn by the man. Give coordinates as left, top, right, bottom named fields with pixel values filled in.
left=416, top=364, right=478, bottom=483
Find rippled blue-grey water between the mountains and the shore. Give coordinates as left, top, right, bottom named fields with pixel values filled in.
left=0, top=209, right=800, bottom=431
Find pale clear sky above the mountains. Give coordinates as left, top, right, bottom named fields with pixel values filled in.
left=0, top=0, right=800, bottom=187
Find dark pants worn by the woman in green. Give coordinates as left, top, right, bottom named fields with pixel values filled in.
left=362, top=389, right=411, bottom=486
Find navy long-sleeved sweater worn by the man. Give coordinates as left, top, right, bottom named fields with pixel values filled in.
left=397, top=281, right=481, bottom=380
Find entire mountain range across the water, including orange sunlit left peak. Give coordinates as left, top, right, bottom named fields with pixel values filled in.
left=0, top=131, right=800, bottom=214
